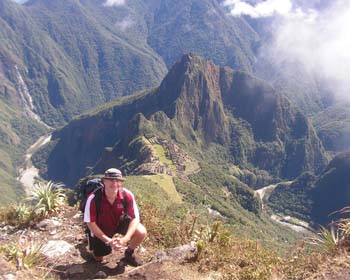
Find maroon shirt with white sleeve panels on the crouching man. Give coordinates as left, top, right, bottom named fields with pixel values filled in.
left=84, top=189, right=139, bottom=237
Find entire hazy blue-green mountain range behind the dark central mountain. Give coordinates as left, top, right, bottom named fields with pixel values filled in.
left=0, top=0, right=258, bottom=201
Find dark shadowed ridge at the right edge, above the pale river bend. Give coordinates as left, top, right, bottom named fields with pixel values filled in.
left=269, top=152, right=350, bottom=224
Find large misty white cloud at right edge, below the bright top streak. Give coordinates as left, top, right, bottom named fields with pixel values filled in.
left=265, top=0, right=350, bottom=97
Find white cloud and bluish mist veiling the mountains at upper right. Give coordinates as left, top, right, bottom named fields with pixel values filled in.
left=223, top=0, right=350, bottom=151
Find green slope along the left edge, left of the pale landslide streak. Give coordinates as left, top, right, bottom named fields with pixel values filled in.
left=0, top=0, right=46, bottom=204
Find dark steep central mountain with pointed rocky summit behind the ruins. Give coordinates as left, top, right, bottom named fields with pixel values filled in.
left=37, top=54, right=327, bottom=184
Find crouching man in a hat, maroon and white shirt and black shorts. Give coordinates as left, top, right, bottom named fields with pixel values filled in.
left=84, top=168, right=147, bottom=266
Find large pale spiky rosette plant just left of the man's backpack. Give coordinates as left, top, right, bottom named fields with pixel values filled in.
left=28, top=181, right=66, bottom=217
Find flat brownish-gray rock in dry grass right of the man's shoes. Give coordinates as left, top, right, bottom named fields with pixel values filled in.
left=153, top=242, right=197, bottom=261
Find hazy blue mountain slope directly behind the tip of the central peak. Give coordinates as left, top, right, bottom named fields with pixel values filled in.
left=148, top=0, right=259, bottom=72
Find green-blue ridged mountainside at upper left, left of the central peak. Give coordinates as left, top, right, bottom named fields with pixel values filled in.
left=0, top=0, right=166, bottom=199
